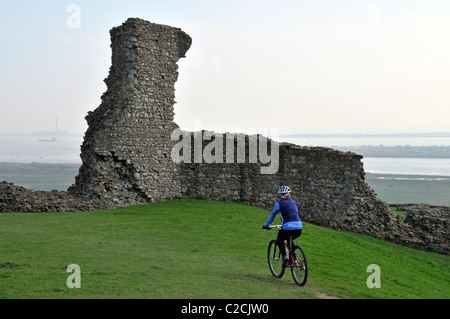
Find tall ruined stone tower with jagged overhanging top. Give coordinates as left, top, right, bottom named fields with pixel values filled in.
left=69, top=18, right=191, bottom=205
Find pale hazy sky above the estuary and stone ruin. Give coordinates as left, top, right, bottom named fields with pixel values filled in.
left=0, top=0, right=450, bottom=134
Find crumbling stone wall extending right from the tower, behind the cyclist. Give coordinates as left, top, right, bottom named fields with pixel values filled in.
left=180, top=137, right=400, bottom=240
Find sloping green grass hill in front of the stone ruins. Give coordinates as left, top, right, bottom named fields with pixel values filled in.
left=0, top=199, right=450, bottom=299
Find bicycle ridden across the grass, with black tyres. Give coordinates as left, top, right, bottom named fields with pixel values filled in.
left=267, top=225, right=308, bottom=286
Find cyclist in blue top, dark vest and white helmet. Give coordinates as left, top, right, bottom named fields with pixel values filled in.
left=263, top=186, right=303, bottom=265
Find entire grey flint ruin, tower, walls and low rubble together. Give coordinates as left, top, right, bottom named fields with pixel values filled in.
left=0, top=18, right=450, bottom=254
